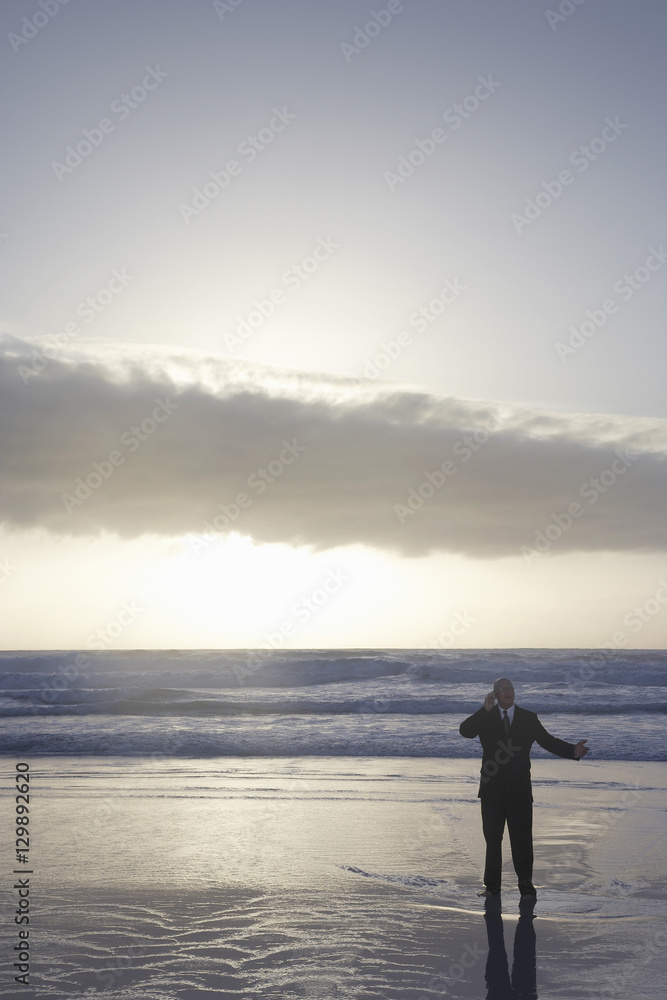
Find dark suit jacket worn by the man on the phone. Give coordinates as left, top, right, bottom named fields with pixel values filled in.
left=459, top=705, right=575, bottom=802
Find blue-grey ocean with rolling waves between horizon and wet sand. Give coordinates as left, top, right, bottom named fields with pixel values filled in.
left=0, top=649, right=667, bottom=761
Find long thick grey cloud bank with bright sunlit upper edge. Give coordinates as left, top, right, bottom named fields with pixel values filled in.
left=0, top=338, right=667, bottom=558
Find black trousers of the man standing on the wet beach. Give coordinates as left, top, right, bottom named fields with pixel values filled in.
left=482, top=797, right=533, bottom=892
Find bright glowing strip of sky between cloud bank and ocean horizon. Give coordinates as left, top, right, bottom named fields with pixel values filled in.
left=0, top=531, right=667, bottom=653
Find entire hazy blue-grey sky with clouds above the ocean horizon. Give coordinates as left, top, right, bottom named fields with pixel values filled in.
left=0, top=0, right=667, bottom=650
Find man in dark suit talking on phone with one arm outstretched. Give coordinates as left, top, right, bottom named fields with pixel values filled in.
left=459, top=677, right=589, bottom=901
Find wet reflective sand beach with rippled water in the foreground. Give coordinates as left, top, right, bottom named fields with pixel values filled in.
left=0, top=754, right=667, bottom=1000
